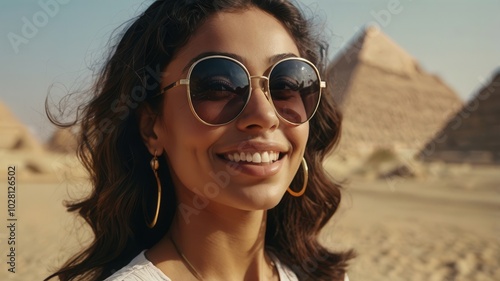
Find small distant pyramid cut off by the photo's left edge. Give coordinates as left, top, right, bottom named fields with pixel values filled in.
left=0, top=98, right=43, bottom=152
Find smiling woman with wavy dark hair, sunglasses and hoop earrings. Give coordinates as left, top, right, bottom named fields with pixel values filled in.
left=48, top=0, right=353, bottom=281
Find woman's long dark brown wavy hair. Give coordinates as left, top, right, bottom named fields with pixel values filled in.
left=45, top=0, right=354, bottom=281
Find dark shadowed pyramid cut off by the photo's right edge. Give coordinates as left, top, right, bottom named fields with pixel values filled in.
left=419, top=71, right=500, bottom=165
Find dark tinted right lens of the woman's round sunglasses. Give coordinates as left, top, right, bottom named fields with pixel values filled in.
left=269, top=59, right=320, bottom=124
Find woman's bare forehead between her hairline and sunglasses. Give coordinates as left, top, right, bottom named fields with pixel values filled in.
left=171, top=8, right=299, bottom=71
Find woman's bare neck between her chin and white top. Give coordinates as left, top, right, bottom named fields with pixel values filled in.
left=172, top=202, right=270, bottom=280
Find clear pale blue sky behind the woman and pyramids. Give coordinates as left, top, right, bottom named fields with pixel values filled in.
left=0, top=0, right=500, bottom=139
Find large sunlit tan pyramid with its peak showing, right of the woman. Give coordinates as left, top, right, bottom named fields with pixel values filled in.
left=328, top=27, right=462, bottom=156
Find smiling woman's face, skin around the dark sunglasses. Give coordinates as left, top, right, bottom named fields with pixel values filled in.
left=154, top=8, right=309, bottom=210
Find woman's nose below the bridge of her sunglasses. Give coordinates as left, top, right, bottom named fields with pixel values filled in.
left=236, top=76, right=280, bottom=132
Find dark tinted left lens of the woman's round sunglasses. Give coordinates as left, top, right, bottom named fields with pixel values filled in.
left=189, top=58, right=249, bottom=125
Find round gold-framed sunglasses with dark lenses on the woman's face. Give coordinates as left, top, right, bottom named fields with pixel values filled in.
left=158, top=55, right=326, bottom=126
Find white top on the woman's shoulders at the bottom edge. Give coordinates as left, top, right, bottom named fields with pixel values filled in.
left=104, top=251, right=349, bottom=281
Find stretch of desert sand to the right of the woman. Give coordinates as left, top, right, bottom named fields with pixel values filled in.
left=323, top=165, right=500, bottom=281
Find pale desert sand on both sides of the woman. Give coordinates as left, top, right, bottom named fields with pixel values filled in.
left=0, top=158, right=500, bottom=281
